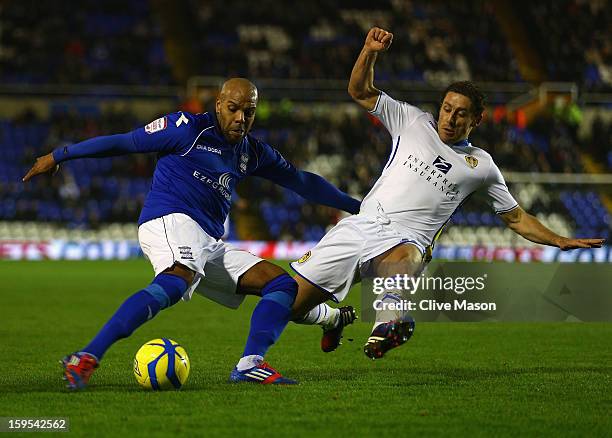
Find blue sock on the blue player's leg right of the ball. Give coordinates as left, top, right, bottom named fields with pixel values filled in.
left=242, top=274, right=298, bottom=357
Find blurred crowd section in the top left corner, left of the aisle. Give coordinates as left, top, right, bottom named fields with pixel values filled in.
left=0, top=0, right=173, bottom=85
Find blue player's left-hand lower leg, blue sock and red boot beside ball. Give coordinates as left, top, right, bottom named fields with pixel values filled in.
left=61, top=265, right=193, bottom=389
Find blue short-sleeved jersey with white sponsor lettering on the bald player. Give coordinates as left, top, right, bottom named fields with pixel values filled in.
left=132, top=112, right=297, bottom=239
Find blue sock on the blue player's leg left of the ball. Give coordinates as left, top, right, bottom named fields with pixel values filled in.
left=81, top=273, right=188, bottom=360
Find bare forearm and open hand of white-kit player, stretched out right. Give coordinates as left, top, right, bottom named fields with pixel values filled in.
left=500, top=207, right=605, bottom=251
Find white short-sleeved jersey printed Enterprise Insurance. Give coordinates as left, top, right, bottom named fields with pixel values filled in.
left=360, top=93, right=518, bottom=247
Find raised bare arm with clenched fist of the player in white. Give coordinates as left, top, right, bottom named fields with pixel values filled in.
left=348, top=27, right=393, bottom=111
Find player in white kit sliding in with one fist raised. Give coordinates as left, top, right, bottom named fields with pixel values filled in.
left=291, top=27, right=604, bottom=359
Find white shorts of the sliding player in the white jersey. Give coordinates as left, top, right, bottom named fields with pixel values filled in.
left=291, top=215, right=425, bottom=303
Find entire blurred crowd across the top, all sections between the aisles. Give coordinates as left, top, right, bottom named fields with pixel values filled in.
left=0, top=0, right=612, bottom=90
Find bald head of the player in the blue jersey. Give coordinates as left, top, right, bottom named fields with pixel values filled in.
left=215, top=78, right=258, bottom=143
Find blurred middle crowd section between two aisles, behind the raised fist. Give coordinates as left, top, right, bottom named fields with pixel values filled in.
left=191, top=0, right=520, bottom=83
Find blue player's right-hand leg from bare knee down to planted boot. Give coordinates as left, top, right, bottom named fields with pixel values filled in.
left=230, top=261, right=297, bottom=384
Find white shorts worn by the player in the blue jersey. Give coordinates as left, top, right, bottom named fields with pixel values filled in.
left=138, top=213, right=263, bottom=309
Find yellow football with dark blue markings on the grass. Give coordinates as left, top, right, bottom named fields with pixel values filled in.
left=134, top=338, right=190, bottom=391
